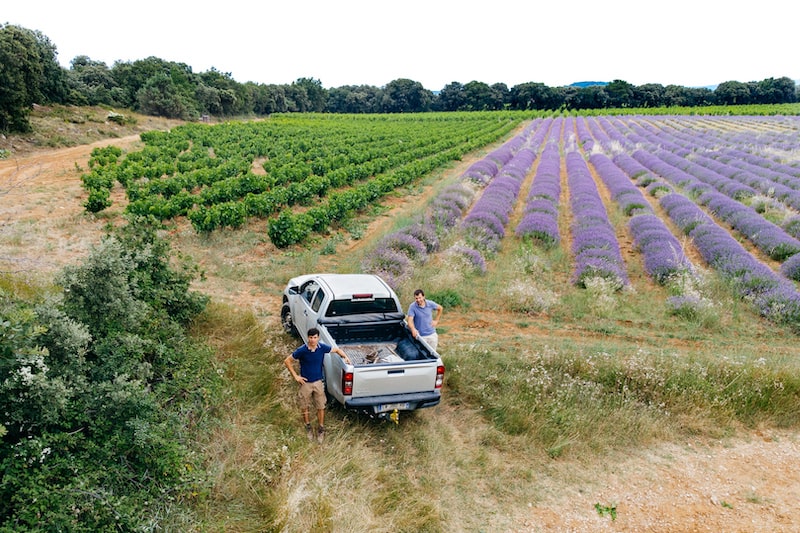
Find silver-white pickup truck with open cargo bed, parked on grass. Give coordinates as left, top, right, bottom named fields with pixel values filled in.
left=281, top=274, right=444, bottom=422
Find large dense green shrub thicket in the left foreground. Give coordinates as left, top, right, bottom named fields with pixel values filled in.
left=0, top=215, right=220, bottom=531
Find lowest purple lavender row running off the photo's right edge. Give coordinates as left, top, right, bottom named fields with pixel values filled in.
left=660, top=193, right=800, bottom=324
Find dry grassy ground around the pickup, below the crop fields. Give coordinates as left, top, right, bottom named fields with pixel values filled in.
left=0, top=106, right=800, bottom=532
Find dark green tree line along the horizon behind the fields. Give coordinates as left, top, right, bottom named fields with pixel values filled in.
left=0, top=24, right=798, bottom=132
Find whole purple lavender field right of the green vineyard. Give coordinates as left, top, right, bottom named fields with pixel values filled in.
left=362, top=112, right=800, bottom=328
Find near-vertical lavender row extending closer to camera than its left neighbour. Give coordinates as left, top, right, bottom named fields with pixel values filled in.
left=566, top=152, right=628, bottom=289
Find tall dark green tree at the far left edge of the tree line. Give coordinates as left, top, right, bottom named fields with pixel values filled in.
left=0, top=25, right=44, bottom=132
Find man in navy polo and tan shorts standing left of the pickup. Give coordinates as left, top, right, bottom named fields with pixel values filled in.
left=283, top=328, right=350, bottom=443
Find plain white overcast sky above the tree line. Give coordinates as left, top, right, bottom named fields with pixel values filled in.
left=0, top=0, right=800, bottom=91
